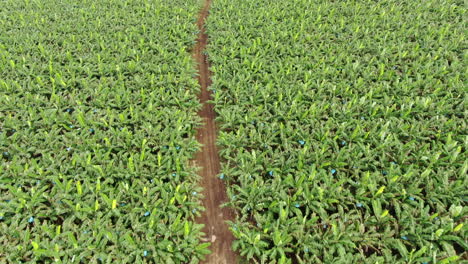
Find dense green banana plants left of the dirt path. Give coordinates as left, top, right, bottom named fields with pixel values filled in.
left=0, top=0, right=208, bottom=263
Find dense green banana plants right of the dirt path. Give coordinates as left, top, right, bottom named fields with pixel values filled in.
left=207, top=0, right=468, bottom=263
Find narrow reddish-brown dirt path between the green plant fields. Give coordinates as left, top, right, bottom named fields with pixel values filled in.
left=193, top=0, right=237, bottom=264
